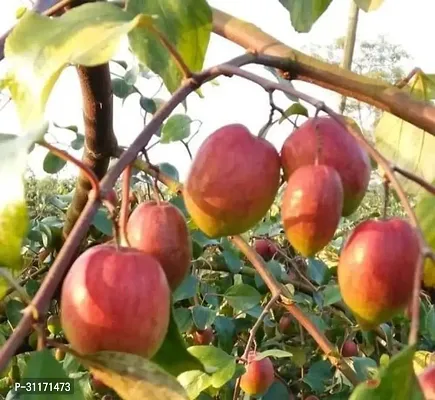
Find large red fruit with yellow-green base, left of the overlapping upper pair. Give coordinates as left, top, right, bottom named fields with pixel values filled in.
left=184, top=124, right=281, bottom=238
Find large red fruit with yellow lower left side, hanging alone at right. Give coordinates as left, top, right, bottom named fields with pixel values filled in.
left=337, top=218, right=420, bottom=330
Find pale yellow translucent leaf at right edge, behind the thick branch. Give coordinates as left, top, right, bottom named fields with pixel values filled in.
left=375, top=73, right=435, bottom=195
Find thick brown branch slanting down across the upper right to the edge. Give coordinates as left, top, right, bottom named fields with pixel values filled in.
left=213, top=9, right=435, bottom=135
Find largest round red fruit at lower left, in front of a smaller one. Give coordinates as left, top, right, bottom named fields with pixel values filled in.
left=60, top=245, right=170, bottom=357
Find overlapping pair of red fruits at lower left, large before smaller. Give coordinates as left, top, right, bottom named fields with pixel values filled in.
left=60, top=201, right=191, bottom=358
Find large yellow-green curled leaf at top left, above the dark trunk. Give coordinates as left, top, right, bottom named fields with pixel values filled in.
left=4, top=2, right=148, bottom=127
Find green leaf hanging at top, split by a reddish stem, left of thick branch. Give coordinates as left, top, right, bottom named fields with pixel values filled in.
left=126, top=0, right=212, bottom=93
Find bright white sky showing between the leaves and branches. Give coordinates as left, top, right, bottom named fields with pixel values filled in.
left=0, top=0, right=435, bottom=180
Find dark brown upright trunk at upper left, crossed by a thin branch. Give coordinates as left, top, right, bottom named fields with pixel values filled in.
left=63, top=64, right=117, bottom=238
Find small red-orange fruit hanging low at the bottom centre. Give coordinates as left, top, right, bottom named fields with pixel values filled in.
left=240, top=351, right=275, bottom=396
